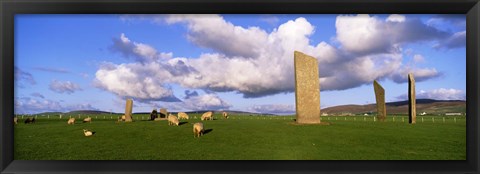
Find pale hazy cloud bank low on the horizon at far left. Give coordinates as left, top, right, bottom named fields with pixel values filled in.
left=14, top=97, right=98, bottom=114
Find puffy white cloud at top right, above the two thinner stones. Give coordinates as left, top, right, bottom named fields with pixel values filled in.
left=335, top=15, right=449, bottom=54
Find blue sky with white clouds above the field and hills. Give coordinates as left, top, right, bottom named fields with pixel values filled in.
left=14, top=14, right=466, bottom=114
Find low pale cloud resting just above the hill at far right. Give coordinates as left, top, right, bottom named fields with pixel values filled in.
left=397, top=88, right=466, bottom=100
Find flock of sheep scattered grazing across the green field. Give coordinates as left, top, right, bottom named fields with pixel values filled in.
left=13, top=110, right=228, bottom=137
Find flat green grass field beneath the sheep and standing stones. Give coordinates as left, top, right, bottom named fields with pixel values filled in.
left=14, top=115, right=466, bottom=160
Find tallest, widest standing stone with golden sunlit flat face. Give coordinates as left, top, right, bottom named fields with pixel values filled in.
left=294, top=51, right=320, bottom=124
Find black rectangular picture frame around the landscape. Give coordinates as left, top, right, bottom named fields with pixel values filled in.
left=0, top=0, right=480, bottom=173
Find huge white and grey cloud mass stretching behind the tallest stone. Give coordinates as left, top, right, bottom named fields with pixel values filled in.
left=95, top=15, right=458, bottom=102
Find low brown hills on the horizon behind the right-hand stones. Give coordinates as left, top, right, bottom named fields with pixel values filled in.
left=321, top=99, right=466, bottom=115
